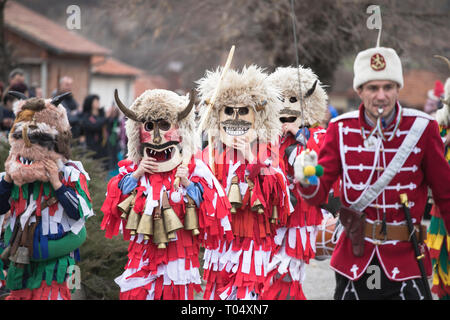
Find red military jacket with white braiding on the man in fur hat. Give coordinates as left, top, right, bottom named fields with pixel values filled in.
left=300, top=104, right=450, bottom=281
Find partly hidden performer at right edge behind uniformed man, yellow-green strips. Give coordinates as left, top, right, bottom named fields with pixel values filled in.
left=427, top=57, right=450, bottom=300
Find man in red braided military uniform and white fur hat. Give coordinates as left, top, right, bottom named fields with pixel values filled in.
left=294, top=47, right=450, bottom=299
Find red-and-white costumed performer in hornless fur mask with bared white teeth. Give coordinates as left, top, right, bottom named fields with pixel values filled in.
left=199, top=66, right=292, bottom=300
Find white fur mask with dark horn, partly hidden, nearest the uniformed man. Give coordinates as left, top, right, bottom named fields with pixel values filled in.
left=268, top=66, right=328, bottom=128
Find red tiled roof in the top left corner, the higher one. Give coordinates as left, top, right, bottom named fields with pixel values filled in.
left=5, top=1, right=111, bottom=55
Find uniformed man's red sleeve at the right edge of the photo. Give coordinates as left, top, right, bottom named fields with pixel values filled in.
left=422, top=121, right=450, bottom=232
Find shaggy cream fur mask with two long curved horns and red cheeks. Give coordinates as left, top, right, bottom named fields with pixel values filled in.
left=115, top=89, right=198, bottom=172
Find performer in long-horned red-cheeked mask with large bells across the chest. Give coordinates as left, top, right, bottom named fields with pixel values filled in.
left=102, top=89, right=232, bottom=300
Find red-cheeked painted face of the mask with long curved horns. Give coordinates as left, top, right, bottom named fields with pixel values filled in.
left=140, top=119, right=181, bottom=172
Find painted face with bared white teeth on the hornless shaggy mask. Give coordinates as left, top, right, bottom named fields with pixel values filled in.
left=219, top=104, right=256, bottom=147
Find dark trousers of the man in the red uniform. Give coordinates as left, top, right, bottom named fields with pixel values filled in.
left=334, top=255, right=425, bottom=300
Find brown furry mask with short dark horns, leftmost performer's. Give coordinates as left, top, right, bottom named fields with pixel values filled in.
left=5, top=91, right=72, bottom=186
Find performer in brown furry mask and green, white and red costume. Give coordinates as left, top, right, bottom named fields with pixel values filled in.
left=0, top=92, right=93, bottom=300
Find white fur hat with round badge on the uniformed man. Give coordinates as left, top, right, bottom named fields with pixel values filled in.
left=353, top=47, right=403, bottom=91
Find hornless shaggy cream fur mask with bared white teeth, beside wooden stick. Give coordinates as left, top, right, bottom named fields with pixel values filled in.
left=198, top=65, right=280, bottom=147
